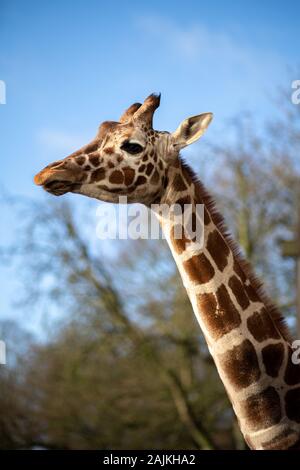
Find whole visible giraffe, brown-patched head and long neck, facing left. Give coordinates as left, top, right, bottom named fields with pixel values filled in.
left=34, top=94, right=300, bottom=450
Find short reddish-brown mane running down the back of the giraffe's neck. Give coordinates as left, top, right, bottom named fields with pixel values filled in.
left=180, top=156, right=292, bottom=344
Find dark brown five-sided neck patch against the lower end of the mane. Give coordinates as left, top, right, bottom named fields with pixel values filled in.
left=247, top=307, right=280, bottom=343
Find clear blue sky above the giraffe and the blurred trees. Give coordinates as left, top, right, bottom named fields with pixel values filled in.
left=0, top=0, right=300, bottom=336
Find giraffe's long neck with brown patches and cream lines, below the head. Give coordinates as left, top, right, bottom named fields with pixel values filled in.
left=156, top=161, right=300, bottom=449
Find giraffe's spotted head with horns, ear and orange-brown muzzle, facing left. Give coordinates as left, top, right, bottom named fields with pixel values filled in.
left=34, top=94, right=212, bottom=205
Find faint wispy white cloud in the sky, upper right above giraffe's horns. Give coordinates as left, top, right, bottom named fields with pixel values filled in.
left=135, top=15, right=286, bottom=111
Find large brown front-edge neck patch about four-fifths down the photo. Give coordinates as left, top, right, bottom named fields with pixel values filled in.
left=219, top=339, right=261, bottom=390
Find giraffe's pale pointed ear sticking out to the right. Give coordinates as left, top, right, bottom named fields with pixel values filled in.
left=172, top=113, right=213, bottom=148
